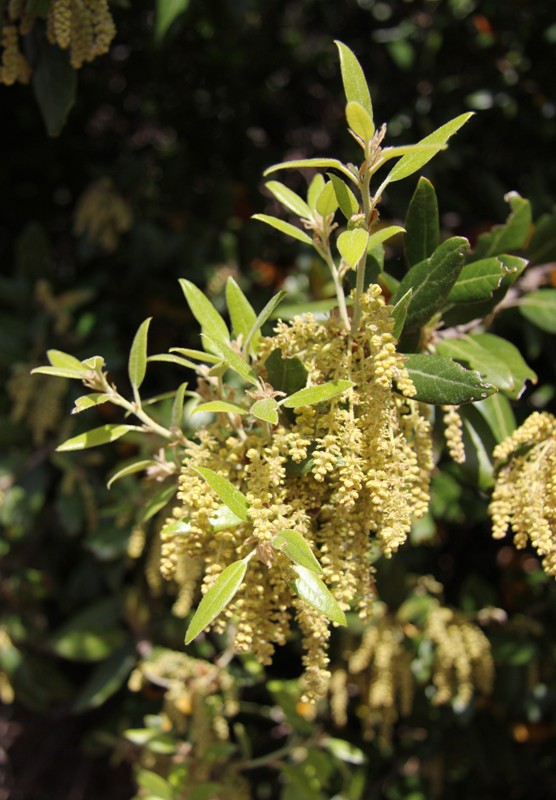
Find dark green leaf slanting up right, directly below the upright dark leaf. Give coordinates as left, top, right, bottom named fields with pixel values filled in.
left=392, top=236, right=469, bottom=331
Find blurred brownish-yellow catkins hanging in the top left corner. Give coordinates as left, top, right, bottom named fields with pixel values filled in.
left=0, top=0, right=116, bottom=86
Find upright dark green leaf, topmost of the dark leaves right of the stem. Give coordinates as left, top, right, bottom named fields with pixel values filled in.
left=404, top=177, right=440, bottom=267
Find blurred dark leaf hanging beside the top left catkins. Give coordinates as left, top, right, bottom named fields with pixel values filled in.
left=31, top=25, right=77, bottom=136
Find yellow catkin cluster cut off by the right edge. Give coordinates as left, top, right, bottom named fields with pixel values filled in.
left=489, top=411, right=556, bottom=576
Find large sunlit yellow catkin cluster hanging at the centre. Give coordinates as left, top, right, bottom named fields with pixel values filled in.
left=161, top=286, right=432, bottom=698
